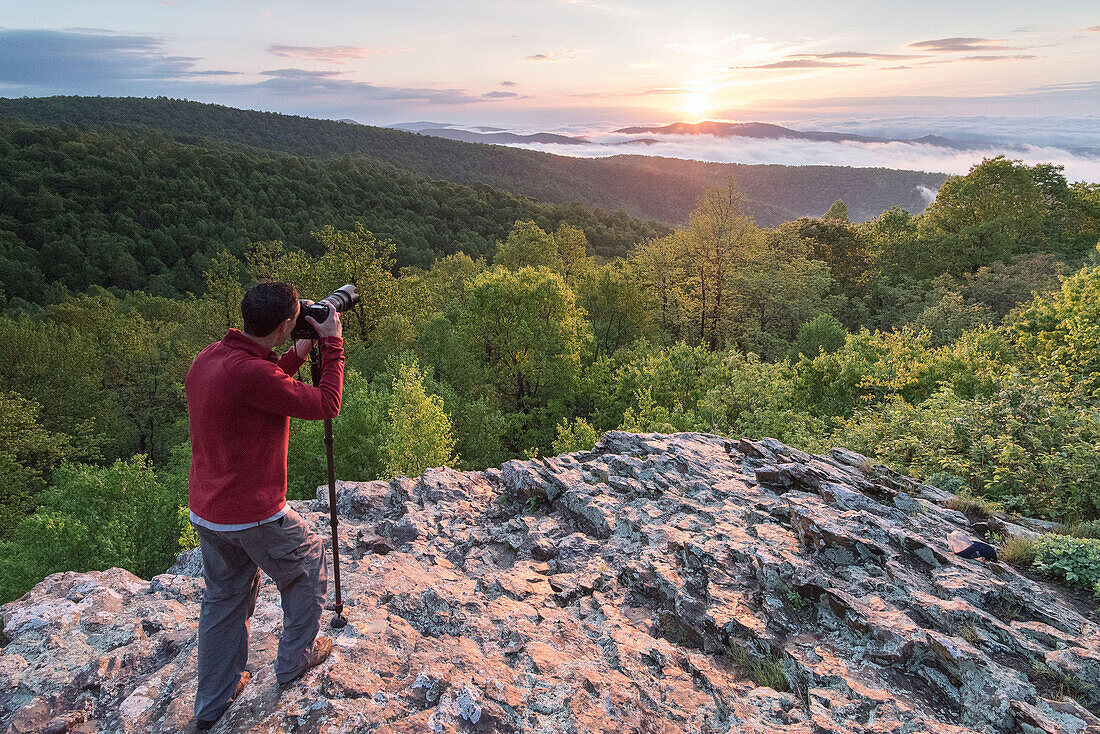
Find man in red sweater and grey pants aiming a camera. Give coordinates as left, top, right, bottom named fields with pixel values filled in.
left=184, top=281, right=344, bottom=731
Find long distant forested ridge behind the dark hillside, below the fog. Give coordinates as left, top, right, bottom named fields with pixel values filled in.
left=0, top=97, right=945, bottom=227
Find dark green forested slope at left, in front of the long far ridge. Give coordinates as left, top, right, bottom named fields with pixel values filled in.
left=0, top=118, right=667, bottom=303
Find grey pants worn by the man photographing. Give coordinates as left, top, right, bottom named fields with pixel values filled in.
left=194, top=508, right=329, bottom=721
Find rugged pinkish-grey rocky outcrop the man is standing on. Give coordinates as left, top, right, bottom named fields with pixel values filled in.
left=0, top=432, right=1100, bottom=734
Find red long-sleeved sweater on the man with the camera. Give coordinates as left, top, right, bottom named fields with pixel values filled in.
left=184, top=329, right=344, bottom=524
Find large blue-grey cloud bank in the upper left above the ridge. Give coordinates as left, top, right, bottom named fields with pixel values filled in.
left=0, top=30, right=234, bottom=91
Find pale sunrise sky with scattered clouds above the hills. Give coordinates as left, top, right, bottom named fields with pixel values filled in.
left=0, top=0, right=1100, bottom=173
